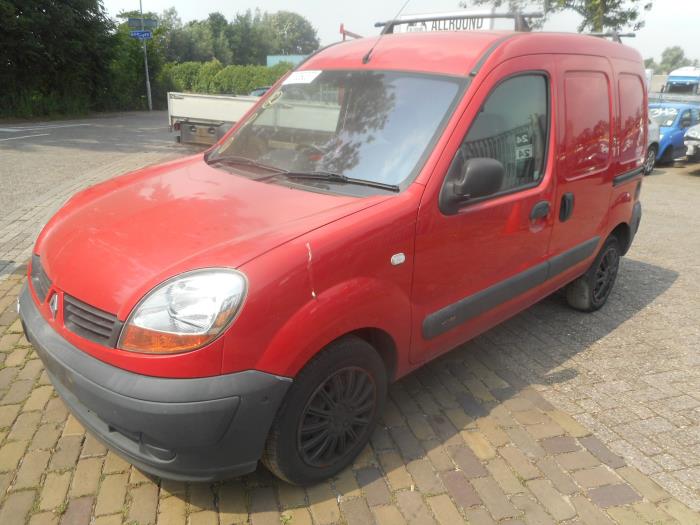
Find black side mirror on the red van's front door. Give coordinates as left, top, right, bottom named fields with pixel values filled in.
left=439, top=153, right=505, bottom=215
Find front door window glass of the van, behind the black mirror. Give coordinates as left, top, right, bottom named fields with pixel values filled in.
left=458, top=74, right=549, bottom=193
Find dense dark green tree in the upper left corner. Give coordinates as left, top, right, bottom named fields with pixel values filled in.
left=0, top=0, right=113, bottom=116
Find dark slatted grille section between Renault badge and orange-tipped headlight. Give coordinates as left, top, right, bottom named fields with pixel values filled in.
left=63, top=294, right=122, bottom=347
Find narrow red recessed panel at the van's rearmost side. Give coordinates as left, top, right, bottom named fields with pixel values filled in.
left=618, top=74, right=645, bottom=164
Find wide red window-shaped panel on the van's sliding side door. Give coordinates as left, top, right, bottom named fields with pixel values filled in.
left=564, top=71, right=610, bottom=179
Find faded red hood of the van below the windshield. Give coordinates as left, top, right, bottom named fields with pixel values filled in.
left=35, top=151, right=387, bottom=319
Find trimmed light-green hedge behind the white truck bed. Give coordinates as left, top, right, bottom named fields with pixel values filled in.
left=158, top=59, right=293, bottom=95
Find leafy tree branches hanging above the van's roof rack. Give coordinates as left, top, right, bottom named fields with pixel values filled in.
left=460, top=0, right=652, bottom=32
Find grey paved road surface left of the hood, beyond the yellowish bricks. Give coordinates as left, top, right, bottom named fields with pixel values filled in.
left=0, top=111, right=196, bottom=276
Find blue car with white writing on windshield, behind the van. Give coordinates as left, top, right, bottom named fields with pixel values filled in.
left=649, top=102, right=700, bottom=163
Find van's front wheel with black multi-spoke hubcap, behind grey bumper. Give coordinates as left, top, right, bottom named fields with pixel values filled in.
left=262, top=336, right=387, bottom=485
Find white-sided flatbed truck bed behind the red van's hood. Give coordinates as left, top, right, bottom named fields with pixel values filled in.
left=168, top=92, right=258, bottom=145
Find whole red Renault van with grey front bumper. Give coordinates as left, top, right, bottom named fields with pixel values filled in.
left=19, top=23, right=647, bottom=485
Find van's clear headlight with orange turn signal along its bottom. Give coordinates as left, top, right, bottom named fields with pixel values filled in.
left=117, top=268, right=247, bottom=354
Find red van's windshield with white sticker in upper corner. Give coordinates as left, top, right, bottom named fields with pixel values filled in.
left=207, top=70, right=464, bottom=194
